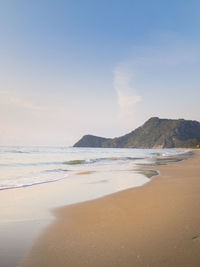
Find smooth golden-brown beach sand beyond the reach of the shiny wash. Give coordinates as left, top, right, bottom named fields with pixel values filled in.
left=22, top=151, right=200, bottom=267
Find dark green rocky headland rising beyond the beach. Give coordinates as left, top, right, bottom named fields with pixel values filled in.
left=74, top=117, right=200, bottom=148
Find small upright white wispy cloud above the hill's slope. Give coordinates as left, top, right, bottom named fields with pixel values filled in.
left=114, top=66, right=142, bottom=118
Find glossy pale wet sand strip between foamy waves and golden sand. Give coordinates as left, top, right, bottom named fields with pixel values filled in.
left=0, top=149, right=177, bottom=267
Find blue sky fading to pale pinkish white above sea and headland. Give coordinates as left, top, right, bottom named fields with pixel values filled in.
left=0, top=0, right=200, bottom=146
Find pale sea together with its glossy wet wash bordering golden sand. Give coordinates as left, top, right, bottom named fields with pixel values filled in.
left=0, top=146, right=191, bottom=267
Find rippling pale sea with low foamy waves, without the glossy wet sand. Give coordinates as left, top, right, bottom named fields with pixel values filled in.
left=0, top=146, right=188, bottom=191
